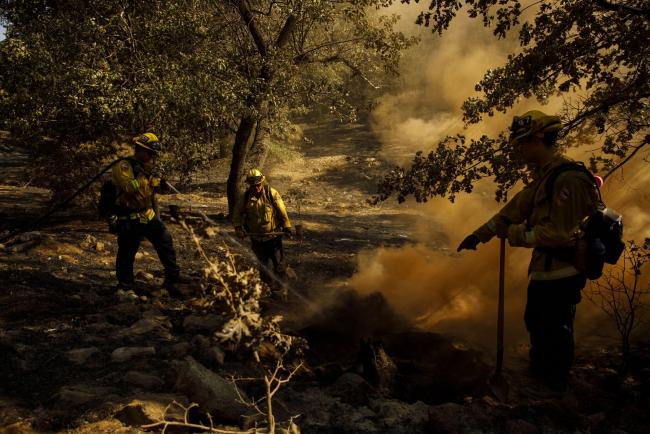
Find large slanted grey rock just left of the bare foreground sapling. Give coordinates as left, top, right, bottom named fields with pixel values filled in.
left=174, top=356, right=250, bottom=421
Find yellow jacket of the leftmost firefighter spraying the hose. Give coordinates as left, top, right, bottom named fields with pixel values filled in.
left=111, top=159, right=160, bottom=223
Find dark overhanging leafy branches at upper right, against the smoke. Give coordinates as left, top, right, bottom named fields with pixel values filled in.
left=377, top=0, right=650, bottom=201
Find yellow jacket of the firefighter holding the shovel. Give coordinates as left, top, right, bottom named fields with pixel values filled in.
left=474, top=155, right=598, bottom=280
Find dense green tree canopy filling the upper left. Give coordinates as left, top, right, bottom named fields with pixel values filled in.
left=0, top=0, right=412, bottom=197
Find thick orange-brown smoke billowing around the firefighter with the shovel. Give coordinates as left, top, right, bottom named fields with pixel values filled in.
left=350, top=8, right=650, bottom=346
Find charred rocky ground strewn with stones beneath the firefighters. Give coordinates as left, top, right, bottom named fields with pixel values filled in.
left=0, top=123, right=650, bottom=434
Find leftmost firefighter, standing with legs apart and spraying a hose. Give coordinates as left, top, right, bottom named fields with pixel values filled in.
left=112, top=133, right=180, bottom=294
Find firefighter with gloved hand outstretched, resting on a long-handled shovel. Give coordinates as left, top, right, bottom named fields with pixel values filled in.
left=458, top=110, right=598, bottom=391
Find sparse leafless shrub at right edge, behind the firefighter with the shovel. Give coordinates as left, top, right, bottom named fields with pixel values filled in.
left=587, top=238, right=650, bottom=369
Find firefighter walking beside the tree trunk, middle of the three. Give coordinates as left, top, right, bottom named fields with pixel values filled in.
left=232, top=169, right=293, bottom=287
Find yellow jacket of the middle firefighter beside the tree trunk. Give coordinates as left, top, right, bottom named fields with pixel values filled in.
left=232, top=185, right=291, bottom=241
